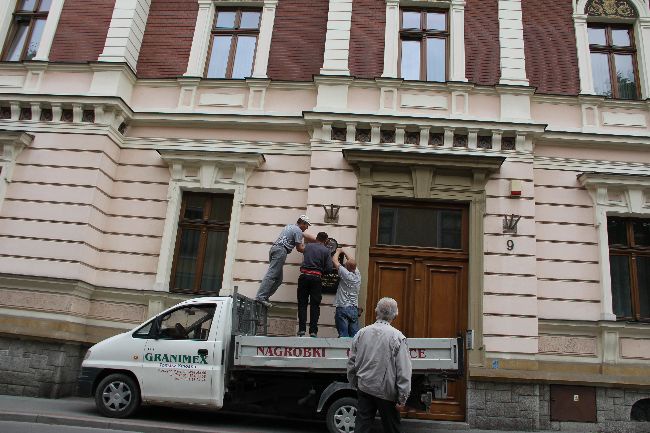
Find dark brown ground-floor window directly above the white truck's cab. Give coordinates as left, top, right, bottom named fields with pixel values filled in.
left=170, top=193, right=232, bottom=295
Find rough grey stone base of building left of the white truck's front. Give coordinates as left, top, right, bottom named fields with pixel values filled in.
left=0, top=336, right=87, bottom=398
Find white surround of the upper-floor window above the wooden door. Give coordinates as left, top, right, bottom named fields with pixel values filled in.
left=382, top=0, right=467, bottom=81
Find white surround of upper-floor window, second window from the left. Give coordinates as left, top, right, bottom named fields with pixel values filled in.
left=183, top=0, right=279, bottom=78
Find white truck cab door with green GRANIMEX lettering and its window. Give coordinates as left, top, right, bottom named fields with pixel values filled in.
left=142, top=303, right=223, bottom=406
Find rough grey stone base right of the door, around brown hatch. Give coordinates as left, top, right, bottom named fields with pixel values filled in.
left=467, top=381, right=650, bottom=433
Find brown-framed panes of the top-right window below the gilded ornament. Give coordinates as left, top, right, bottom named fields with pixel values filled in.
left=587, top=23, right=639, bottom=99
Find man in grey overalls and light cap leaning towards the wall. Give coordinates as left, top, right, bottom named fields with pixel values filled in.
left=255, top=215, right=316, bottom=307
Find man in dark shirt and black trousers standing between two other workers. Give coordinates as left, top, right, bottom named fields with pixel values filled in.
left=298, top=232, right=333, bottom=337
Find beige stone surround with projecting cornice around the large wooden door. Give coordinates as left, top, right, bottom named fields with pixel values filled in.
left=343, top=146, right=505, bottom=365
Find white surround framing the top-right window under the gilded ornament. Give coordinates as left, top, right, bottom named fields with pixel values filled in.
left=573, top=0, right=650, bottom=100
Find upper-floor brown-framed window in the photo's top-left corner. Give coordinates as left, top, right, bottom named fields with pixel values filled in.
left=2, top=0, right=52, bottom=62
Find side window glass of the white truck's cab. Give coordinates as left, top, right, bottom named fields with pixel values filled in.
left=158, top=305, right=215, bottom=341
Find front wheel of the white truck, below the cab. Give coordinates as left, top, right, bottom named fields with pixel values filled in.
left=95, top=373, right=140, bottom=418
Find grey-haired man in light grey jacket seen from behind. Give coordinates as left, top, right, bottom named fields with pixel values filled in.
left=347, top=298, right=412, bottom=433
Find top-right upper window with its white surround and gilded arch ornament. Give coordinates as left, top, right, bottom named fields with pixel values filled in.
left=574, top=0, right=650, bottom=99
